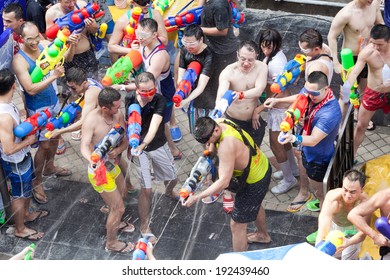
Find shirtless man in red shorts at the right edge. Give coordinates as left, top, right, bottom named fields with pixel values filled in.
left=342, top=24, right=390, bottom=158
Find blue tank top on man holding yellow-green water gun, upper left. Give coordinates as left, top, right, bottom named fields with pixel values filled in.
left=19, top=45, right=58, bottom=111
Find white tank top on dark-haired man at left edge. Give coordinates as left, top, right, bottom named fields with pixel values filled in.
left=0, top=103, right=30, bottom=163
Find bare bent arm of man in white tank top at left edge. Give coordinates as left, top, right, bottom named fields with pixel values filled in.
left=0, top=114, right=37, bottom=156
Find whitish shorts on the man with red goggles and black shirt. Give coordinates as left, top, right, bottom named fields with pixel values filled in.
left=131, top=143, right=177, bottom=188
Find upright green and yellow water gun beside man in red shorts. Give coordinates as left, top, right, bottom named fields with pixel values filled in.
left=340, top=48, right=360, bottom=108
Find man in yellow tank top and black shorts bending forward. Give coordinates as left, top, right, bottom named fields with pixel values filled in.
left=183, top=117, right=272, bottom=252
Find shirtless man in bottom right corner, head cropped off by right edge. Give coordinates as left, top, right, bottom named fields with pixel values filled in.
left=348, top=189, right=390, bottom=260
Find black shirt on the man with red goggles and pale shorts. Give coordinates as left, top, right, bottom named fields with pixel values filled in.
left=128, top=92, right=167, bottom=152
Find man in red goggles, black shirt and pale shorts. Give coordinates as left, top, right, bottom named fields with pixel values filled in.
left=128, top=72, right=178, bottom=244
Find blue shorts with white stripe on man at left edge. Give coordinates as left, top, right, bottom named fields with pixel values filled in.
left=1, top=153, right=35, bottom=198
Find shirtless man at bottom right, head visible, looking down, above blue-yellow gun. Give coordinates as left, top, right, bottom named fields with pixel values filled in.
left=316, top=169, right=368, bottom=260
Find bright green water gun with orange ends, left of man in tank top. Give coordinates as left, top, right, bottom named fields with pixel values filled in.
left=102, top=50, right=142, bottom=87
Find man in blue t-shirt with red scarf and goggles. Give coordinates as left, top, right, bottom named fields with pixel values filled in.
left=264, top=71, right=341, bottom=211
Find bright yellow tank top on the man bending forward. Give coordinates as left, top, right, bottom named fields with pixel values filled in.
left=216, top=119, right=268, bottom=184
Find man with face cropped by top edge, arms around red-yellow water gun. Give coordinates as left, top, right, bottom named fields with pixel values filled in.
left=108, top=0, right=168, bottom=56
